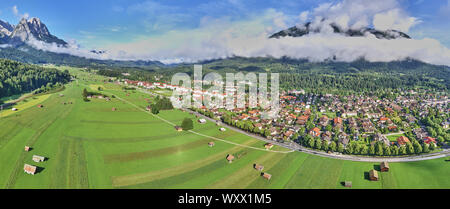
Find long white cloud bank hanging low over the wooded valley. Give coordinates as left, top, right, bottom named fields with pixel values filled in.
left=25, top=0, right=450, bottom=66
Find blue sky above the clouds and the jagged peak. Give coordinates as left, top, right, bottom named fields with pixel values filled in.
left=0, top=0, right=450, bottom=48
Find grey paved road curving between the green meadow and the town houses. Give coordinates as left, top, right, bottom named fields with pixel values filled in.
left=140, top=85, right=450, bottom=162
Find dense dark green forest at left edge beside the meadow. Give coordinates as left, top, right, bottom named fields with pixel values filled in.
left=0, top=59, right=70, bottom=98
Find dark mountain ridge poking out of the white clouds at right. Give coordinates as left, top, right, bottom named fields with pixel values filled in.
left=270, top=22, right=411, bottom=39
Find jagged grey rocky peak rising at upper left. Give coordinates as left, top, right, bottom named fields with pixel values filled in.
left=9, top=18, right=67, bottom=46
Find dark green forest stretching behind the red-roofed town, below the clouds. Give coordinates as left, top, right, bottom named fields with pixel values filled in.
left=98, top=57, right=450, bottom=93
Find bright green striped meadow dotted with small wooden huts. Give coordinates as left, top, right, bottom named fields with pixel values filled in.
left=0, top=68, right=450, bottom=189
